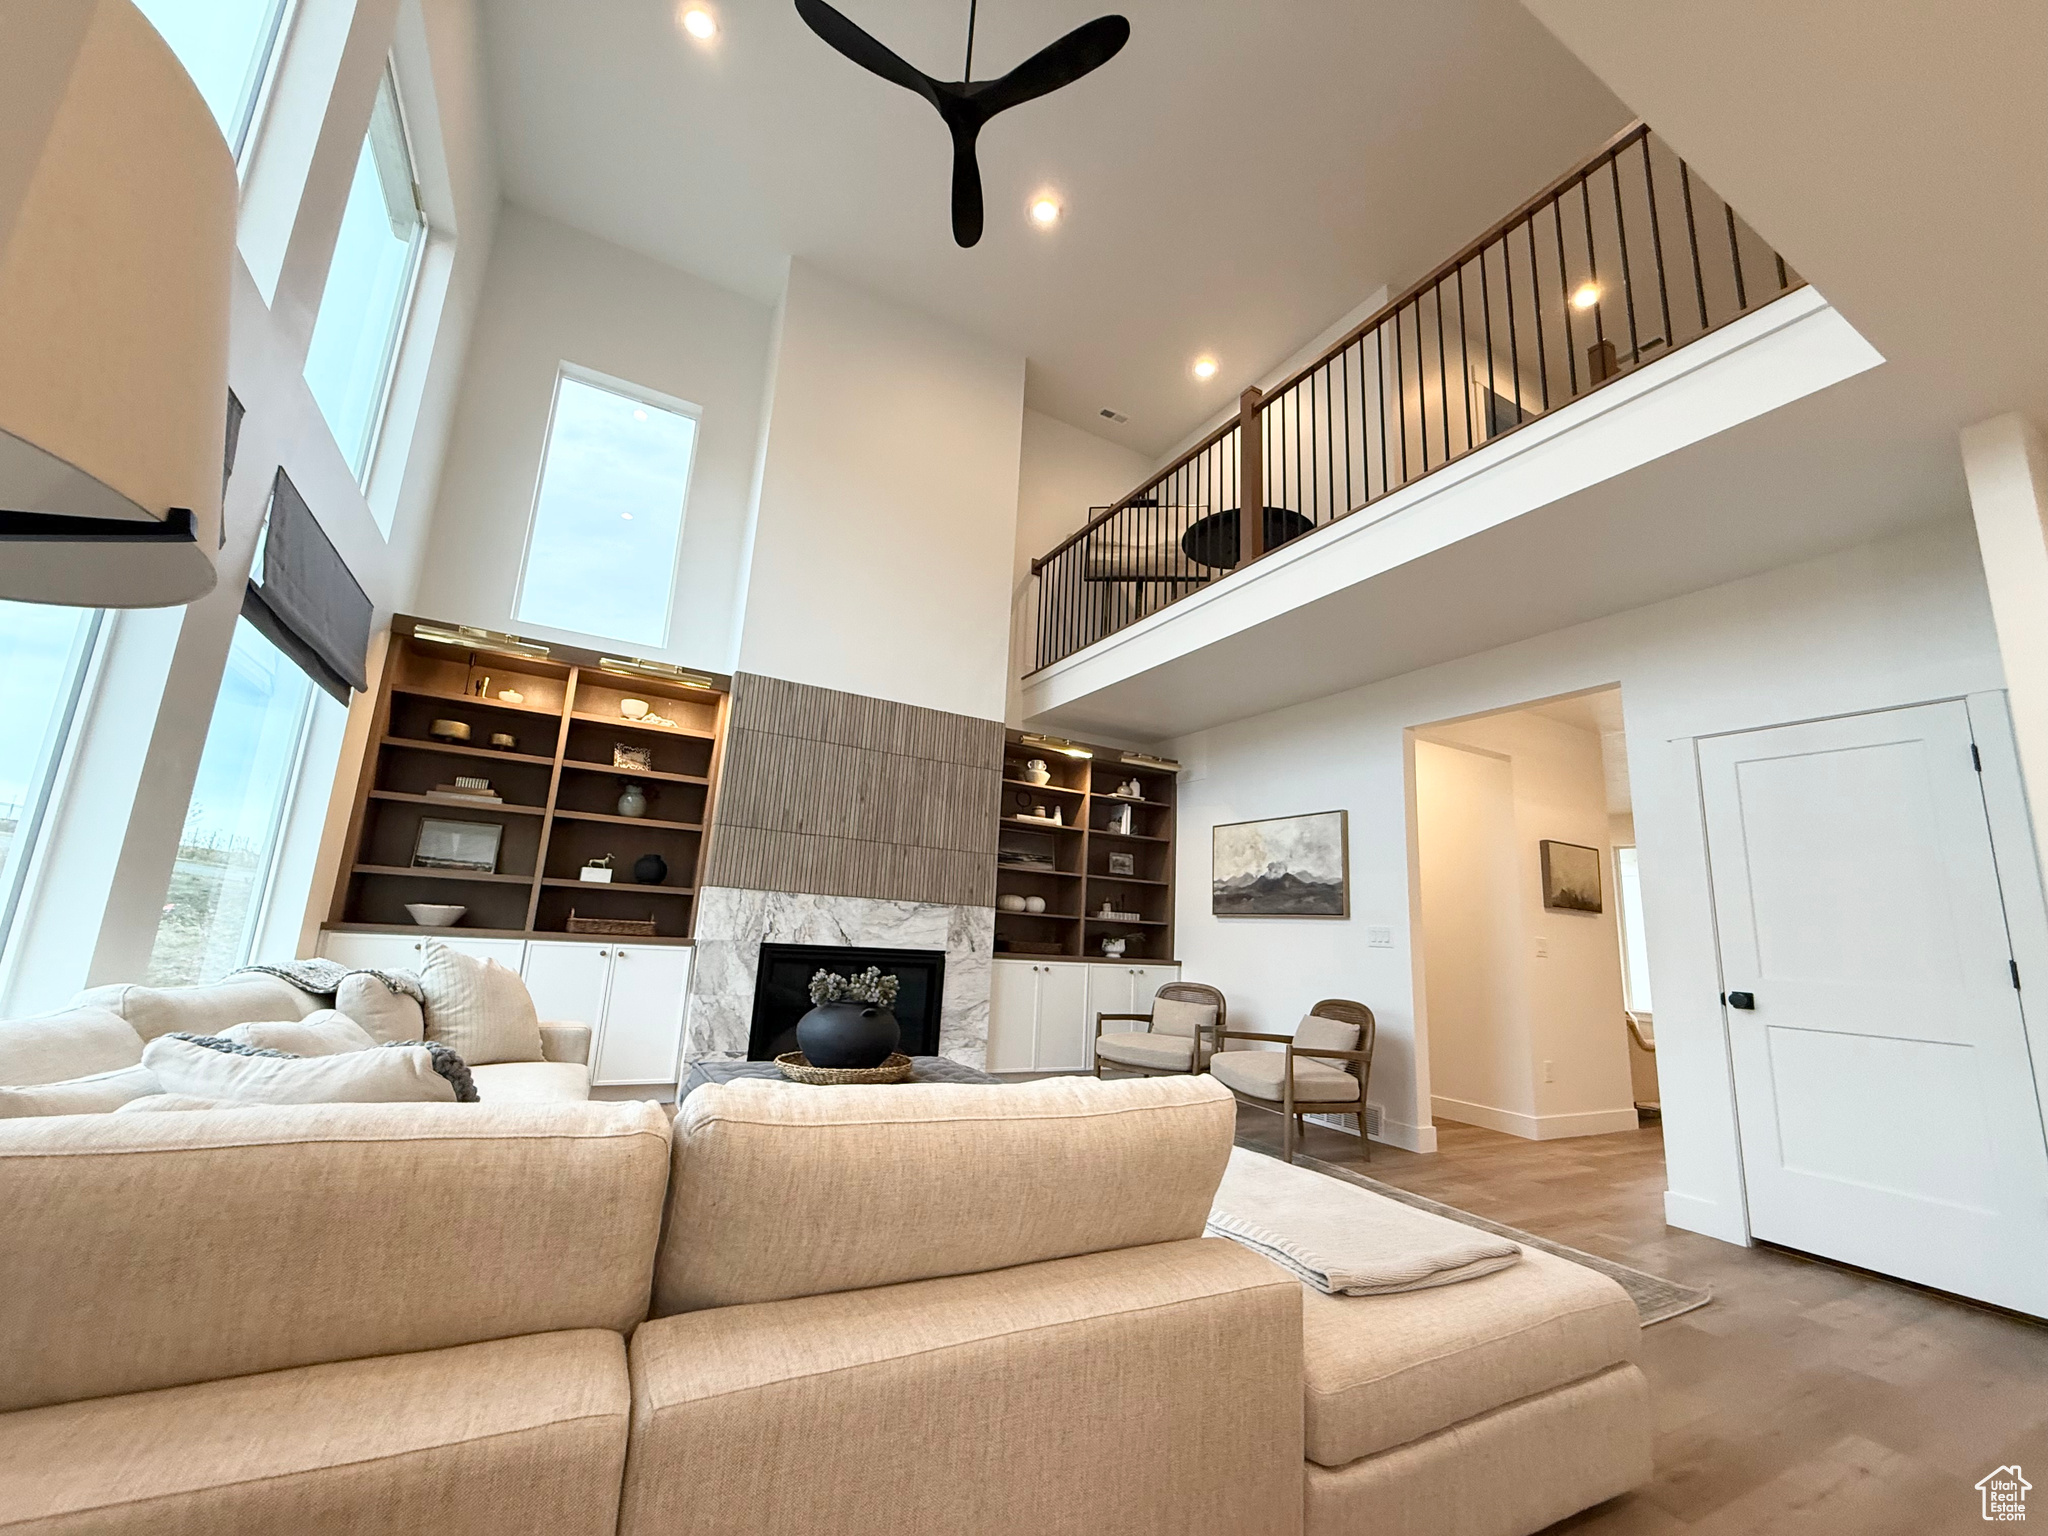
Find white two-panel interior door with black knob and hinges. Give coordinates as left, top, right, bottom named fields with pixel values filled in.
left=1700, top=702, right=2048, bottom=1315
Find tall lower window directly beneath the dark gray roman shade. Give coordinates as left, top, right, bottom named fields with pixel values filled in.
left=147, top=618, right=313, bottom=987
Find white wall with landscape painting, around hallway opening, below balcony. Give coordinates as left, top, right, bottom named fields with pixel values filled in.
left=1169, top=520, right=2003, bottom=1241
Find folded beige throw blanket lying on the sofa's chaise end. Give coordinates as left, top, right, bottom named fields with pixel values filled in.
left=1208, top=1147, right=1522, bottom=1296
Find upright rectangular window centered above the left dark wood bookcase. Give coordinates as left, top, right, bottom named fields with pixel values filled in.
left=516, top=373, right=696, bottom=645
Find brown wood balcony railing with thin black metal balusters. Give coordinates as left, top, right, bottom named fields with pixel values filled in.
left=1032, top=123, right=1804, bottom=668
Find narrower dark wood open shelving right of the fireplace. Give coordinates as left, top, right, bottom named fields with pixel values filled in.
left=995, top=731, right=1178, bottom=963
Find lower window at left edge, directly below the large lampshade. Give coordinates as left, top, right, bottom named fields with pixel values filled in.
left=0, top=602, right=100, bottom=954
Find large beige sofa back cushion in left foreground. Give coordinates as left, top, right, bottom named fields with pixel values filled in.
left=0, top=1104, right=668, bottom=1417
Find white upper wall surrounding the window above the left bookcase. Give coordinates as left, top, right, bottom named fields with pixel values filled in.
left=412, top=205, right=772, bottom=672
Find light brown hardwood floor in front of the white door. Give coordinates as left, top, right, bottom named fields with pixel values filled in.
left=1237, top=1106, right=2048, bottom=1536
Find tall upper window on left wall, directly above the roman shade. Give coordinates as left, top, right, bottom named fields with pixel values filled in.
left=305, top=68, right=426, bottom=479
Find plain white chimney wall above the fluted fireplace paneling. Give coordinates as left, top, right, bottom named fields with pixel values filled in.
left=739, top=262, right=1024, bottom=719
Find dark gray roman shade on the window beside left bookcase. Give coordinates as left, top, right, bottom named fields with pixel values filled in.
left=242, top=469, right=371, bottom=705
